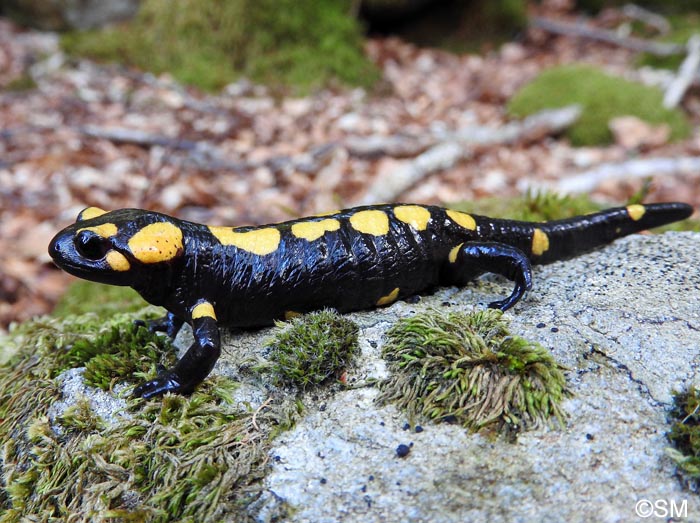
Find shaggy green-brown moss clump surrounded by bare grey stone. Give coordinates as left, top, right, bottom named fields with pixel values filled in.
left=378, top=310, right=567, bottom=431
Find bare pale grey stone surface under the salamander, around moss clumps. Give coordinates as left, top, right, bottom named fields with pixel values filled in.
left=226, top=233, right=700, bottom=522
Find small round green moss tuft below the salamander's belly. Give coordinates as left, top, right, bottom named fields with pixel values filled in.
left=265, top=310, right=359, bottom=389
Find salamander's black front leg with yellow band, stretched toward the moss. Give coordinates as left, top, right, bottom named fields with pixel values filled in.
left=134, top=302, right=221, bottom=399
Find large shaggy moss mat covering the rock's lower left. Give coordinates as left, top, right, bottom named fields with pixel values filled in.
left=0, top=315, right=299, bottom=522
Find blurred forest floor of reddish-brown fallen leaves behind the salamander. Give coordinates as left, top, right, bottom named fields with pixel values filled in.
left=0, top=4, right=700, bottom=328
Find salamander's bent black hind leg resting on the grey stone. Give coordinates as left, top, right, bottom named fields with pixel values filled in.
left=442, top=242, right=532, bottom=311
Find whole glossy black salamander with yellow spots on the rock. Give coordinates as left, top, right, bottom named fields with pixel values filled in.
left=49, top=203, right=693, bottom=398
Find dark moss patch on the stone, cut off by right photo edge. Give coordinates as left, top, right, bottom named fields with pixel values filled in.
left=666, top=387, right=700, bottom=491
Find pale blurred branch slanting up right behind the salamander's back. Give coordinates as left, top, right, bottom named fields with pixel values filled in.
left=361, top=106, right=581, bottom=204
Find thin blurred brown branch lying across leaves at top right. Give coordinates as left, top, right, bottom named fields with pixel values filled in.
left=530, top=16, right=685, bottom=56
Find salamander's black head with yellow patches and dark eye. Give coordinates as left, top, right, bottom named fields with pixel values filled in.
left=49, top=207, right=184, bottom=287
